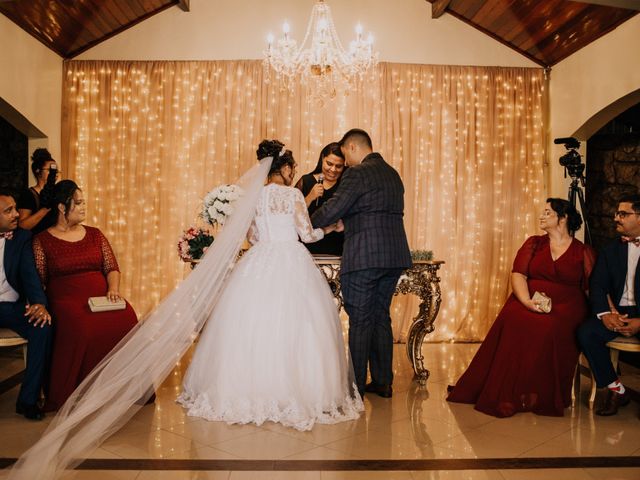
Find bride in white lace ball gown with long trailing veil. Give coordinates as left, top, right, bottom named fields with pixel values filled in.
left=8, top=140, right=363, bottom=480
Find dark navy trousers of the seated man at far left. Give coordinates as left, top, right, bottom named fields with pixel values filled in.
left=0, top=302, right=52, bottom=405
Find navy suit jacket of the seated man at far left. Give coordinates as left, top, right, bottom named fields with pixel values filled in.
left=3, top=228, right=47, bottom=305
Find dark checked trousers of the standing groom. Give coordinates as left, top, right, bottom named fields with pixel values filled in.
left=340, top=268, right=403, bottom=394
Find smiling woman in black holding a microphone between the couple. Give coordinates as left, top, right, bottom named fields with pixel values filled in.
left=296, top=142, right=346, bottom=256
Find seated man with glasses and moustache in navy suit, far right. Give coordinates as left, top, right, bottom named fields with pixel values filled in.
left=578, top=195, right=640, bottom=416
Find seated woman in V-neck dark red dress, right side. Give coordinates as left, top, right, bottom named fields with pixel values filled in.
left=447, top=198, right=595, bottom=417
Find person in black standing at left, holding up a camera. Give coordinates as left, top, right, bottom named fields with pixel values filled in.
left=18, top=148, right=61, bottom=235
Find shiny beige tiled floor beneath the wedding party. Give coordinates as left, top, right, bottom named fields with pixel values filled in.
left=0, top=344, right=640, bottom=480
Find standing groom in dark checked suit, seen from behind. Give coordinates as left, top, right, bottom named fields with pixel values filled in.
left=311, top=128, right=411, bottom=398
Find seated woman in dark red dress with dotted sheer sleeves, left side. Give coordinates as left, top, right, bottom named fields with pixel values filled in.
left=33, top=180, right=137, bottom=411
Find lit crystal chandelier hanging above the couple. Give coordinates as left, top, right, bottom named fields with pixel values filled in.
left=263, top=0, right=378, bottom=101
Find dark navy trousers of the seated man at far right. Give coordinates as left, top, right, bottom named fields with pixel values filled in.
left=578, top=307, right=640, bottom=388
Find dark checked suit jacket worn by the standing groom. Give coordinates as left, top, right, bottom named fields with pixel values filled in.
left=311, top=153, right=411, bottom=273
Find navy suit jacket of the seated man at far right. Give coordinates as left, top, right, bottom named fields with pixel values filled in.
left=589, top=240, right=640, bottom=315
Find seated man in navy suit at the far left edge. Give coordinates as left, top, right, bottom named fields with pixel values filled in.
left=0, top=189, right=51, bottom=420
